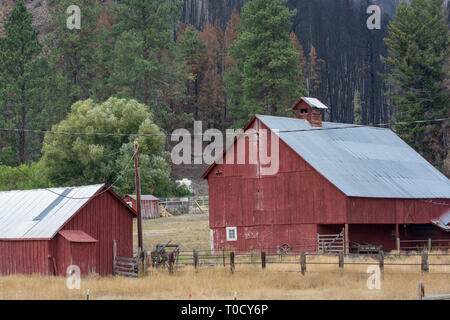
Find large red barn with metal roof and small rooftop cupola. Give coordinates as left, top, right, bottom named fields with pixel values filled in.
left=203, top=98, right=450, bottom=251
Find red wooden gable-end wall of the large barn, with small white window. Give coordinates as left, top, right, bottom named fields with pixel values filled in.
left=208, top=120, right=346, bottom=249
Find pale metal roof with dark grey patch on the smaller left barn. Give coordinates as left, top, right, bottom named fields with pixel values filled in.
left=0, top=184, right=104, bottom=239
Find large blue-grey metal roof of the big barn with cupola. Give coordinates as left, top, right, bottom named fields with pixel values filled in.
left=256, top=115, right=450, bottom=199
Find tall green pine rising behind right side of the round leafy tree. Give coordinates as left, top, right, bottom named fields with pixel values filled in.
left=109, top=0, right=187, bottom=131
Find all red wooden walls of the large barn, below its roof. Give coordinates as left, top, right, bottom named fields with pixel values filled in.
left=204, top=118, right=450, bottom=251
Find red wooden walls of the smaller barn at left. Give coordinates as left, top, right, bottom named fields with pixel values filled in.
left=0, top=189, right=134, bottom=275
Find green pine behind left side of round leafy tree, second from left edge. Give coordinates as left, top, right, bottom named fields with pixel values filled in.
left=46, top=0, right=105, bottom=112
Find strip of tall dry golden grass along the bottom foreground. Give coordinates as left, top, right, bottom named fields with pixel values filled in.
left=0, top=264, right=450, bottom=300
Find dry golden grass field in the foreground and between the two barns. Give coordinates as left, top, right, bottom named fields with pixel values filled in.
left=0, top=215, right=450, bottom=300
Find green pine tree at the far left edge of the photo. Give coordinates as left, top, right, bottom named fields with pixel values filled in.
left=0, top=0, right=53, bottom=165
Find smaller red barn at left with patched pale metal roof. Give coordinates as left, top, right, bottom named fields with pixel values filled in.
left=0, top=185, right=135, bottom=276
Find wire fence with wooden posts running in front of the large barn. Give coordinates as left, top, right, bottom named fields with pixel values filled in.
left=150, top=245, right=450, bottom=274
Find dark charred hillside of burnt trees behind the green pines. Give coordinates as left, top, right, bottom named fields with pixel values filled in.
left=0, top=0, right=399, bottom=124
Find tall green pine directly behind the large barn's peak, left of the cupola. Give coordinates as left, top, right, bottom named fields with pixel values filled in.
left=225, top=0, right=304, bottom=127
